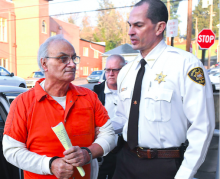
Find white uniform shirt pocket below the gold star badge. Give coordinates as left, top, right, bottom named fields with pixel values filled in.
left=144, top=88, right=173, bottom=122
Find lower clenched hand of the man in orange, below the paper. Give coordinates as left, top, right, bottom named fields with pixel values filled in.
left=51, top=158, right=74, bottom=179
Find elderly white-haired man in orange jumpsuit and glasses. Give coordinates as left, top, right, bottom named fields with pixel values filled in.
left=3, top=35, right=115, bottom=179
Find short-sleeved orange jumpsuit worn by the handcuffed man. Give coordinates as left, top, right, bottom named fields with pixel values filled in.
left=4, top=79, right=109, bottom=179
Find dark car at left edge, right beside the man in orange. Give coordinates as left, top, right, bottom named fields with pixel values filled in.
left=0, top=85, right=28, bottom=179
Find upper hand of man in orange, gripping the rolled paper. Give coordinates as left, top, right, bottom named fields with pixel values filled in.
left=63, top=146, right=90, bottom=167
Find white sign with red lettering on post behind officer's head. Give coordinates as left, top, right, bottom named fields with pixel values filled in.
left=166, top=19, right=178, bottom=46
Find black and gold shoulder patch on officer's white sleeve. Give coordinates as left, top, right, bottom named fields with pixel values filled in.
left=188, top=67, right=205, bottom=86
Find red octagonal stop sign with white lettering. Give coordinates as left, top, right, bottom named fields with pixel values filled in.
left=197, top=29, right=215, bottom=49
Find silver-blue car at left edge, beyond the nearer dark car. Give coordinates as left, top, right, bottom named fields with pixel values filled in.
left=0, top=66, right=27, bottom=88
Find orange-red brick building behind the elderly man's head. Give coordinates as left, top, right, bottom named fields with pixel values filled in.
left=0, top=0, right=105, bottom=78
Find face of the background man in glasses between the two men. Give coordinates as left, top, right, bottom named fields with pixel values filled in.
left=105, top=57, right=122, bottom=89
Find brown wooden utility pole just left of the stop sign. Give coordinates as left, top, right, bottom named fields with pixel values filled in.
left=186, top=0, right=192, bottom=52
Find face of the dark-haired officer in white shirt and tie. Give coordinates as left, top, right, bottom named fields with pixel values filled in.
left=128, top=3, right=157, bottom=56
